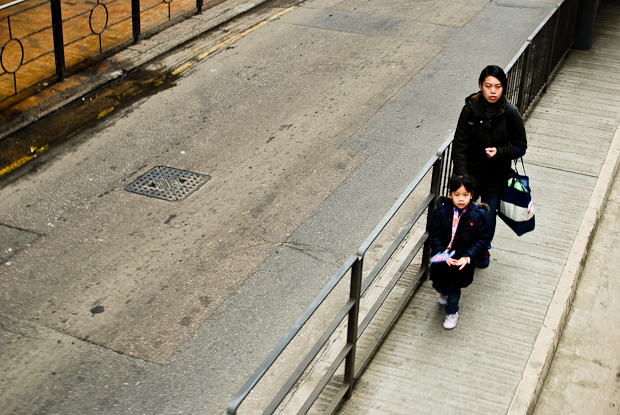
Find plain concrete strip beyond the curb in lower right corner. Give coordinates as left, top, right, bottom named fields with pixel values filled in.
left=534, top=131, right=620, bottom=415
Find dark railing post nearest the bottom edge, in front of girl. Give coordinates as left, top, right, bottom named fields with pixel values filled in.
left=344, top=257, right=364, bottom=399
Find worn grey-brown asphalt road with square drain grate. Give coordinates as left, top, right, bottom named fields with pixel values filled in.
left=0, top=0, right=555, bottom=414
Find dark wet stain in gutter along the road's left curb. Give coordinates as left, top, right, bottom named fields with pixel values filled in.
left=0, top=69, right=178, bottom=180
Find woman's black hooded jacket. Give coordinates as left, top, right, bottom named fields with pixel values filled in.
left=452, top=92, right=527, bottom=196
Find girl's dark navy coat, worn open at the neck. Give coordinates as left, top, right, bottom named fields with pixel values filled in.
left=428, top=197, right=491, bottom=288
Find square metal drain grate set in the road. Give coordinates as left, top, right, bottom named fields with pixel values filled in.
left=125, top=166, right=211, bottom=202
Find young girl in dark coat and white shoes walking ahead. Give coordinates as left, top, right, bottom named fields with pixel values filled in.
left=428, top=174, right=491, bottom=329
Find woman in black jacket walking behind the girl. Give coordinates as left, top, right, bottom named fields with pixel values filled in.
left=452, top=65, right=527, bottom=268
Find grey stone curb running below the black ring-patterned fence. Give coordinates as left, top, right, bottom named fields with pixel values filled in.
left=0, top=0, right=269, bottom=141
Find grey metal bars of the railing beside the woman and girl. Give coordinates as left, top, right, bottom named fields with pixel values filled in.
left=227, top=0, right=581, bottom=415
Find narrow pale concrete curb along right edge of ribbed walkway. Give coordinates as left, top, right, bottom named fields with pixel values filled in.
left=506, top=125, right=620, bottom=415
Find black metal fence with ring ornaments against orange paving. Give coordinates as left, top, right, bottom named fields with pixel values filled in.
left=0, top=0, right=208, bottom=102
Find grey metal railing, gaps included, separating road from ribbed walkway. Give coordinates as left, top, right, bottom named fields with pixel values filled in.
left=227, top=0, right=581, bottom=415
